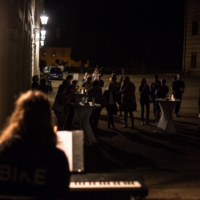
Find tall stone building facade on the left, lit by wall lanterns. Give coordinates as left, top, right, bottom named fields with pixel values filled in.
left=0, top=0, right=44, bottom=129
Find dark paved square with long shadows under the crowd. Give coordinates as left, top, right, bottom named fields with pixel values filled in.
left=49, top=74, right=200, bottom=200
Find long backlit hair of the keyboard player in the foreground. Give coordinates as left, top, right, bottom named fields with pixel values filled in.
left=0, top=91, right=57, bottom=146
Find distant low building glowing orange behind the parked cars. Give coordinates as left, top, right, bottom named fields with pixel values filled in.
left=40, top=47, right=89, bottom=67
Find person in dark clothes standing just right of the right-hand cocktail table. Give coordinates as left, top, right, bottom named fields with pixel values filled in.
left=172, top=74, right=185, bottom=117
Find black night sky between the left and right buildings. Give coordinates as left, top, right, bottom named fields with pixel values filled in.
left=45, top=0, right=184, bottom=68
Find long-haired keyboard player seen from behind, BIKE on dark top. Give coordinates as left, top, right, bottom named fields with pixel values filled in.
left=0, top=91, right=70, bottom=200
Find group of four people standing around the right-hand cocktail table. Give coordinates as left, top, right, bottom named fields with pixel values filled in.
left=139, top=74, right=185, bottom=125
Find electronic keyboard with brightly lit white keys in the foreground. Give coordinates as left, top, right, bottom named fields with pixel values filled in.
left=69, top=173, right=148, bottom=200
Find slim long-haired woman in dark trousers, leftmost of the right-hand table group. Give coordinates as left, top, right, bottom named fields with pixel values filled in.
left=139, top=78, right=150, bottom=125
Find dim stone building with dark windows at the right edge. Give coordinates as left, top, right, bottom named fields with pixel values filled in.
left=183, top=0, right=200, bottom=76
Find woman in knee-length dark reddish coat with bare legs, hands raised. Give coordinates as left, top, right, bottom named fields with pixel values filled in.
left=119, top=76, right=136, bottom=129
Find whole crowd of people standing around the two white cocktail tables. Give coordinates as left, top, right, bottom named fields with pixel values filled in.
left=51, top=69, right=185, bottom=133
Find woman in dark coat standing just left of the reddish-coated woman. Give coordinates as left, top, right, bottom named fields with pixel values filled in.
left=103, top=83, right=118, bottom=129
